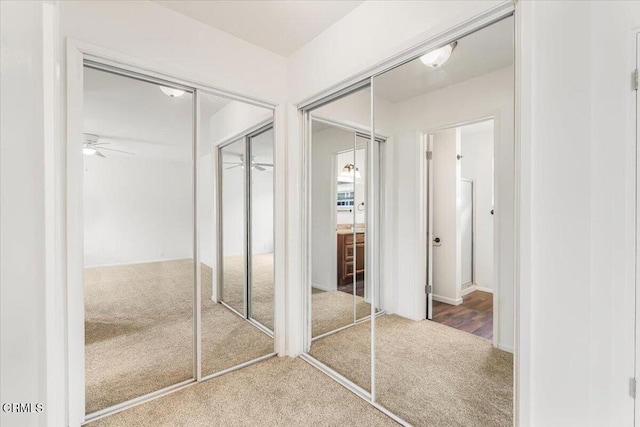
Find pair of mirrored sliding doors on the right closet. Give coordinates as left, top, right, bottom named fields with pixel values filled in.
left=302, top=13, right=515, bottom=427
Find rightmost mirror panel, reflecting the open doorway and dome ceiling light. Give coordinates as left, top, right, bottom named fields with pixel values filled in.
left=373, top=17, right=514, bottom=427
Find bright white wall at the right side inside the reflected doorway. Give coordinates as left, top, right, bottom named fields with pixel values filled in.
left=460, top=121, right=494, bottom=290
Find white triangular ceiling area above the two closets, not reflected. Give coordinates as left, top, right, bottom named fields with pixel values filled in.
left=154, top=0, right=362, bottom=57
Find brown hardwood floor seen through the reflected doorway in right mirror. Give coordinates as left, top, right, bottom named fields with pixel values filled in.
left=433, top=291, right=493, bottom=340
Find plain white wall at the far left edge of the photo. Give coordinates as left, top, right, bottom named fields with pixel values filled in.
left=0, top=2, right=54, bottom=427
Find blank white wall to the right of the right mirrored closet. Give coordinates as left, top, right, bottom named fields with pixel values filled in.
left=520, top=1, right=640, bottom=426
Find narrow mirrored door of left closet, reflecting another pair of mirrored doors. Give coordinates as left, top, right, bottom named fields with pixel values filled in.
left=198, top=92, right=274, bottom=378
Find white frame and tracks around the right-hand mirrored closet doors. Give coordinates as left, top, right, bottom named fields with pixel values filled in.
left=297, top=0, right=521, bottom=425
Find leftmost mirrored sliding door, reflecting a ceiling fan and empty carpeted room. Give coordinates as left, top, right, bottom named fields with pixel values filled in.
left=82, top=67, right=194, bottom=414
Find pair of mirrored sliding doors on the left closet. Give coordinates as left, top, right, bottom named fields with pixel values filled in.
left=81, top=61, right=275, bottom=421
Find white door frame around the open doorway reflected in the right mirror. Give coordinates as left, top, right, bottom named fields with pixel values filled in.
left=414, top=112, right=500, bottom=347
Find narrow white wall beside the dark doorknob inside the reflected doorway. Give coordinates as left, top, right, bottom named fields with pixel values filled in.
left=430, top=128, right=462, bottom=305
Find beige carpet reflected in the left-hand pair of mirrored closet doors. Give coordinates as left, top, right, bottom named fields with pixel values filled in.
left=85, top=260, right=273, bottom=413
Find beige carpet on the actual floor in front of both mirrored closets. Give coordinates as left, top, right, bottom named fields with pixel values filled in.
left=88, top=358, right=397, bottom=427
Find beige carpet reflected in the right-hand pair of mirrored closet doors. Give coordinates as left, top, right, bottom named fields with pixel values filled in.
left=310, top=315, right=513, bottom=427
